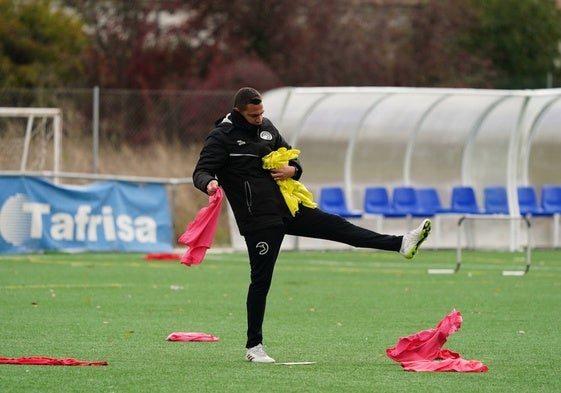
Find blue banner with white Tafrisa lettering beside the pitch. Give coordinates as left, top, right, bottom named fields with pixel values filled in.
left=0, top=176, right=172, bottom=254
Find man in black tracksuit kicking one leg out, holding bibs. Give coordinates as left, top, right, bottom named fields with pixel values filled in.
left=193, top=87, right=431, bottom=363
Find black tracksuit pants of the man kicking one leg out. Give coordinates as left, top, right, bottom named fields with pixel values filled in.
left=244, top=205, right=403, bottom=348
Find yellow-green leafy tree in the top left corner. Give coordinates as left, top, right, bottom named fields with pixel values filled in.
left=0, top=0, right=86, bottom=87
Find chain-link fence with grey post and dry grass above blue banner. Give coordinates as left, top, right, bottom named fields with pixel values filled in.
left=0, top=89, right=235, bottom=244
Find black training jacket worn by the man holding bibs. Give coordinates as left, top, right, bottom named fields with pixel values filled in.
left=193, top=111, right=302, bottom=235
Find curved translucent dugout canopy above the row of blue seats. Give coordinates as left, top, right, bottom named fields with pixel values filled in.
left=263, top=87, right=561, bottom=215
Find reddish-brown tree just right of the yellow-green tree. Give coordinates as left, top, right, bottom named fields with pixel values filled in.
left=64, top=0, right=182, bottom=89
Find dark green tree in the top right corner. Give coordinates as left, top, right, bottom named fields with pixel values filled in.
left=466, top=0, right=561, bottom=88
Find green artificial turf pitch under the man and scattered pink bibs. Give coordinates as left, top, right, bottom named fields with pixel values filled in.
left=0, top=250, right=561, bottom=393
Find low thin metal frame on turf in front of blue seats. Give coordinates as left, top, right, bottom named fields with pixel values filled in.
left=427, top=214, right=532, bottom=276
